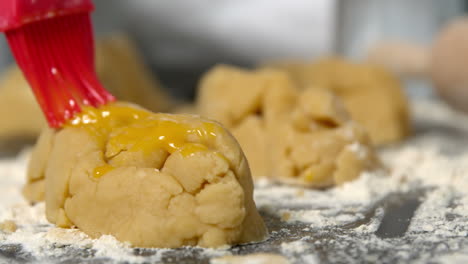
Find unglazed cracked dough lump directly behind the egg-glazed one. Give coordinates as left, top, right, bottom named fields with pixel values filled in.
left=197, top=66, right=380, bottom=187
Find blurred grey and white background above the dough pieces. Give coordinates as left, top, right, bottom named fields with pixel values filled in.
left=0, top=0, right=468, bottom=99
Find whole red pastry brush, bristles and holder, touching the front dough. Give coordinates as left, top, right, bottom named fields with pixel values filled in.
left=0, top=0, right=115, bottom=128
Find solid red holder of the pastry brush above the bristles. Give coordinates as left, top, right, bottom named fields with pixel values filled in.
left=0, top=0, right=94, bottom=31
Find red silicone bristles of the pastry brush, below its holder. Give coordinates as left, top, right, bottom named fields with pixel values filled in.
left=7, top=13, right=115, bottom=128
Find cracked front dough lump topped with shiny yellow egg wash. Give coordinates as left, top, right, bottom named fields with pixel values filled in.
left=25, top=104, right=266, bottom=247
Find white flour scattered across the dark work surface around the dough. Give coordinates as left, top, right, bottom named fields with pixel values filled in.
left=0, top=99, right=468, bottom=263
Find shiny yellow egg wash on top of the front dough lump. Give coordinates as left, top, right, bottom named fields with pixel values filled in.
left=65, top=103, right=224, bottom=178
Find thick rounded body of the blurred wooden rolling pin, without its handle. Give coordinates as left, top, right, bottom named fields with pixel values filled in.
left=430, top=17, right=468, bottom=112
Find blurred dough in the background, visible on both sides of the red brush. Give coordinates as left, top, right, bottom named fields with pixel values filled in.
left=0, top=35, right=172, bottom=141
